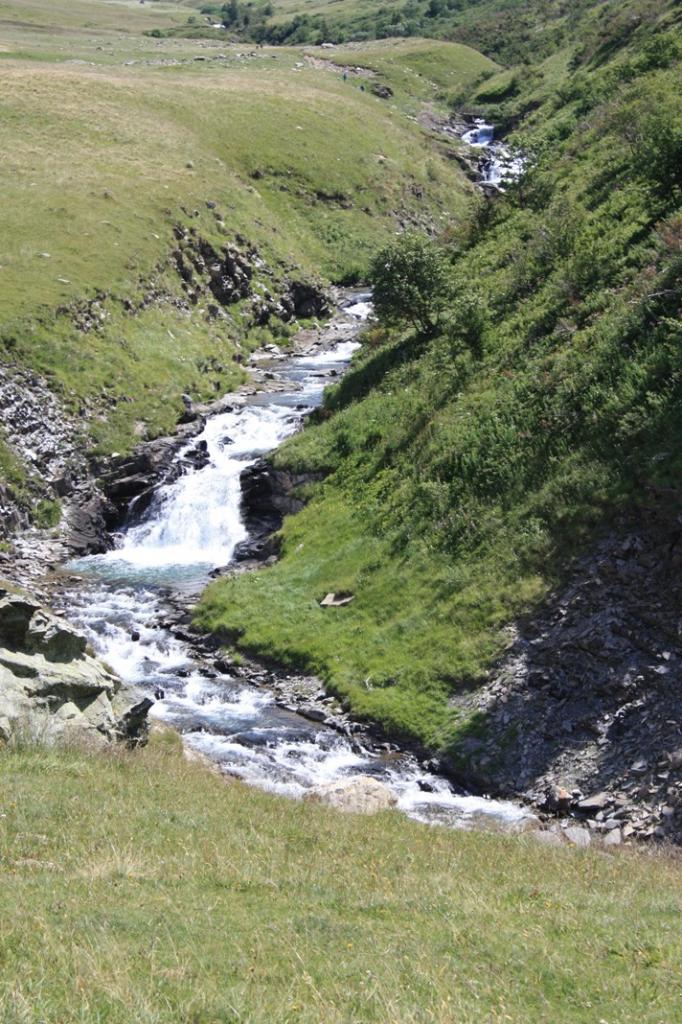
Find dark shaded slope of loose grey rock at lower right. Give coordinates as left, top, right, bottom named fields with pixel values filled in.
left=448, top=516, right=682, bottom=843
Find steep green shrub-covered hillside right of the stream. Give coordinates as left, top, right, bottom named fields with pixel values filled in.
left=200, top=5, right=682, bottom=754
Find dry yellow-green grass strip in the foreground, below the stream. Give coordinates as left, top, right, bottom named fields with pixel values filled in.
left=0, top=736, right=682, bottom=1024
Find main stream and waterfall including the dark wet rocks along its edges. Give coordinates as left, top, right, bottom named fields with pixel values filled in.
left=29, top=294, right=538, bottom=828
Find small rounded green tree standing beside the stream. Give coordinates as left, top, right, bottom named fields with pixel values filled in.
left=370, top=232, right=451, bottom=337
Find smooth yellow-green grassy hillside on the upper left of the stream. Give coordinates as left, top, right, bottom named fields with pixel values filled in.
left=0, top=0, right=477, bottom=468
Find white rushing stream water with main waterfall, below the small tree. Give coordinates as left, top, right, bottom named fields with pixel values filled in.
left=67, top=296, right=527, bottom=825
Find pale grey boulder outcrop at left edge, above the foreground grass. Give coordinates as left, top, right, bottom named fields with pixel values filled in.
left=0, top=589, right=153, bottom=745
